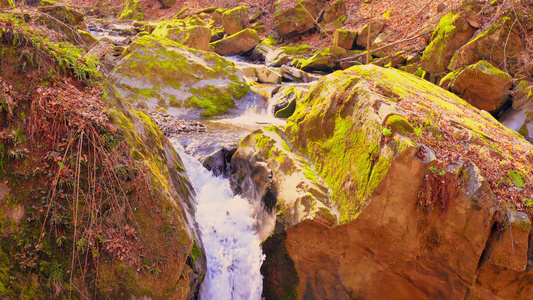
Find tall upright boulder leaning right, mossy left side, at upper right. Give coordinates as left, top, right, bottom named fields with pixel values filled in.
left=421, top=12, right=475, bottom=79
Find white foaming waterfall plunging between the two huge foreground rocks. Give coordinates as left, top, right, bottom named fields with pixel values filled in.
left=180, top=151, right=265, bottom=300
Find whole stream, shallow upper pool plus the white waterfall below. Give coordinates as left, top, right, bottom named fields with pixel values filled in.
left=171, top=93, right=285, bottom=300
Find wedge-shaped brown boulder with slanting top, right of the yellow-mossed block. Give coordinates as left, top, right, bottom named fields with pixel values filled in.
left=211, top=28, right=259, bottom=56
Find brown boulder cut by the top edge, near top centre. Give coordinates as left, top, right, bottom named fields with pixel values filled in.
left=274, top=0, right=324, bottom=38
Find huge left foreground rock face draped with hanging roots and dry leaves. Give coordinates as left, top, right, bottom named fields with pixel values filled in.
left=0, top=15, right=205, bottom=299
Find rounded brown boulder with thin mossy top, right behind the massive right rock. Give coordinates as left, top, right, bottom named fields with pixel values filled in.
left=451, top=60, right=512, bottom=113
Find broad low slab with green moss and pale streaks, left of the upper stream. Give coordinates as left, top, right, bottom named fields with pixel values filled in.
left=111, top=35, right=249, bottom=117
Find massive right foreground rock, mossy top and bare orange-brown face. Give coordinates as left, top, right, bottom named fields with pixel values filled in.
left=232, top=66, right=533, bottom=299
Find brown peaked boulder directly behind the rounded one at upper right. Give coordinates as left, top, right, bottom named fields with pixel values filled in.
left=448, top=18, right=524, bottom=74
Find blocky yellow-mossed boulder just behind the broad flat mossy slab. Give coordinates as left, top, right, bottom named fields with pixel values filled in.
left=152, top=20, right=212, bottom=51
